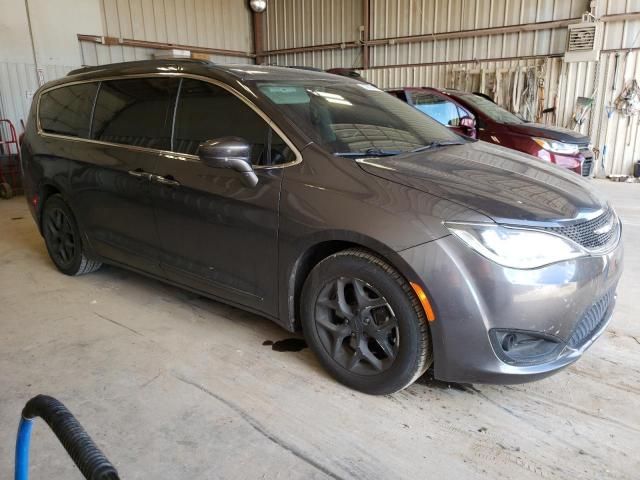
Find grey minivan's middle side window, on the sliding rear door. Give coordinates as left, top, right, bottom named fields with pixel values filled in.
left=91, top=77, right=179, bottom=150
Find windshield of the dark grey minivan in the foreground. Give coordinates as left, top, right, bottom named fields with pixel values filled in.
left=255, top=80, right=465, bottom=157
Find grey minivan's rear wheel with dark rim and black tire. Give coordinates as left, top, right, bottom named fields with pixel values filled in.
left=42, top=194, right=102, bottom=276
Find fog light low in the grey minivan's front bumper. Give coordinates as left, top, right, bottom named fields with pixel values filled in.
left=489, top=329, right=564, bottom=365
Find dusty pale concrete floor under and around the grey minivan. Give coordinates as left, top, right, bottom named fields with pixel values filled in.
left=0, top=182, right=640, bottom=479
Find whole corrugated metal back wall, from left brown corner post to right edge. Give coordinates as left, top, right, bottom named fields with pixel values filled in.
left=265, top=0, right=640, bottom=174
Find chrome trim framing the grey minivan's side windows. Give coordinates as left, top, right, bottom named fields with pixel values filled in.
left=36, top=72, right=302, bottom=170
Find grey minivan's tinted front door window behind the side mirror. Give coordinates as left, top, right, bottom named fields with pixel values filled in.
left=174, top=79, right=295, bottom=165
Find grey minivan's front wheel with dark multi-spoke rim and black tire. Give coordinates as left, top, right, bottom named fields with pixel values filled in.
left=301, top=249, right=433, bottom=395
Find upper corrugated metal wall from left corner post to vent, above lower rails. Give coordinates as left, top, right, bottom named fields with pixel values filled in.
left=265, top=0, right=588, bottom=68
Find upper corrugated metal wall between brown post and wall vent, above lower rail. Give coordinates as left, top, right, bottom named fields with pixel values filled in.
left=371, top=0, right=588, bottom=66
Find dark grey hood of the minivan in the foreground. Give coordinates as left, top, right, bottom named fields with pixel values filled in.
left=358, top=142, right=607, bottom=227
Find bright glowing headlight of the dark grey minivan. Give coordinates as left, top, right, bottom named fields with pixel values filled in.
left=445, top=223, right=588, bottom=269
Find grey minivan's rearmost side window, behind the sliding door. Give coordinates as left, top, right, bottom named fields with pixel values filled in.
left=39, top=83, right=98, bottom=138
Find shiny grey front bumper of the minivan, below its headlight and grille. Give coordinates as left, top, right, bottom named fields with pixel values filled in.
left=400, top=232, right=623, bottom=384
